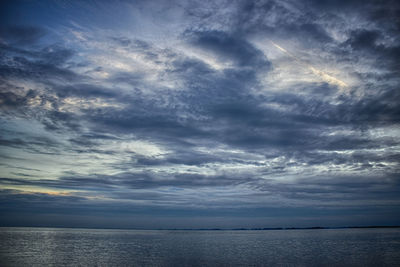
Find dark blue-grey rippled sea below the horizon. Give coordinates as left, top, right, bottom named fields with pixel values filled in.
left=0, top=228, right=400, bottom=266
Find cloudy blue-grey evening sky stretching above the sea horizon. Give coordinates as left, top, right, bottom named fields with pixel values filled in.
left=0, top=0, right=400, bottom=229
